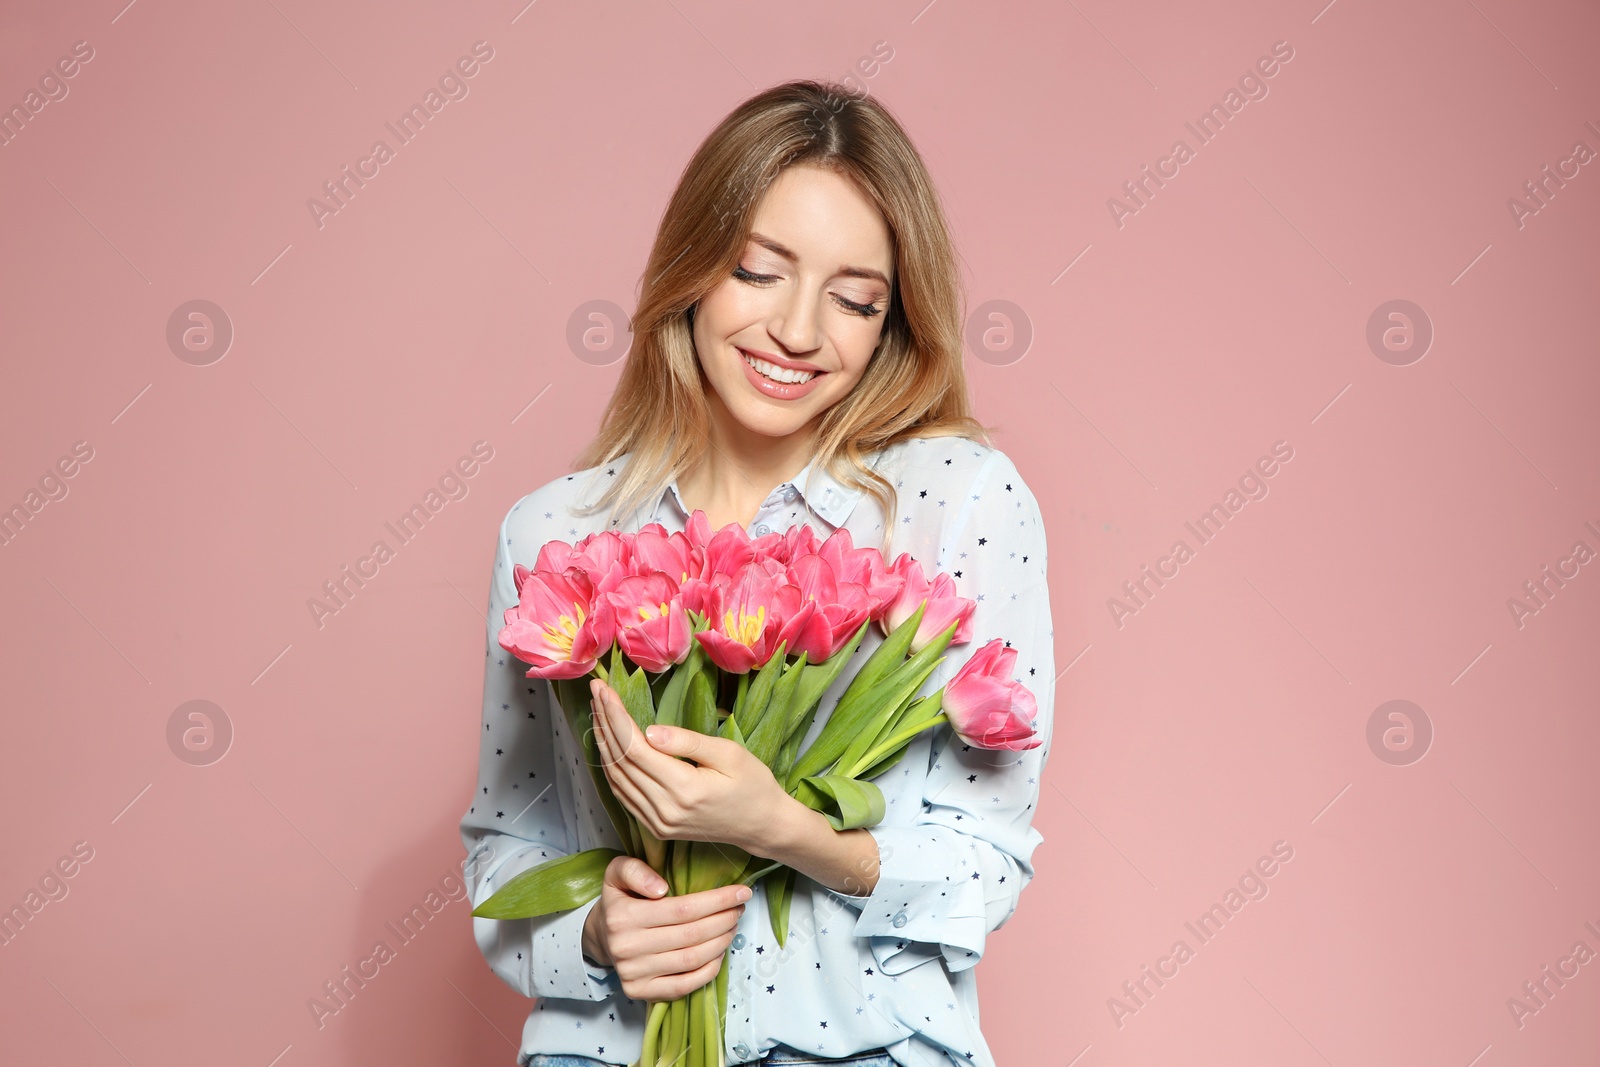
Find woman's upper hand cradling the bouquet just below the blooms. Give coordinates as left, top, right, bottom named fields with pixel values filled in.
left=589, top=678, right=800, bottom=857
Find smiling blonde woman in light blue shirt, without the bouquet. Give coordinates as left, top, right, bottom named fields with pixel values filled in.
left=461, top=82, right=1054, bottom=1067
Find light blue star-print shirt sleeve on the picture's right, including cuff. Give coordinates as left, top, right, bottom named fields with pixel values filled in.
left=819, top=450, right=1056, bottom=974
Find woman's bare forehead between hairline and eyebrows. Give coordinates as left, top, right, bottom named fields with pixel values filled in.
left=752, top=165, right=894, bottom=274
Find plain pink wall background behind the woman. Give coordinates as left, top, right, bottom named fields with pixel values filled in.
left=0, top=0, right=1600, bottom=1067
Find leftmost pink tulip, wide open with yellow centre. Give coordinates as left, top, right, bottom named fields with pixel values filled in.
left=498, top=563, right=614, bottom=678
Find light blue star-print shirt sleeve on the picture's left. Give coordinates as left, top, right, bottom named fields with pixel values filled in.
left=461, top=507, right=621, bottom=1000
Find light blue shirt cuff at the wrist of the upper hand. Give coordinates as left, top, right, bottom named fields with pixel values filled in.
left=818, top=824, right=989, bottom=974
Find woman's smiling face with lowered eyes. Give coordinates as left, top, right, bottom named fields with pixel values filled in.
left=694, top=165, right=894, bottom=437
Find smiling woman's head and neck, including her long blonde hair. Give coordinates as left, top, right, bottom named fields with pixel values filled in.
left=576, top=82, right=987, bottom=544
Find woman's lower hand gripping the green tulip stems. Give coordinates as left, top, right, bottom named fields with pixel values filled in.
left=582, top=856, right=750, bottom=1001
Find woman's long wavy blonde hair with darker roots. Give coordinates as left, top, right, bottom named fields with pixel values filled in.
left=574, top=80, right=990, bottom=550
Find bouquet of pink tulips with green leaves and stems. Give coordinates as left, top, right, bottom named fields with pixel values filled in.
left=472, top=510, right=1040, bottom=1067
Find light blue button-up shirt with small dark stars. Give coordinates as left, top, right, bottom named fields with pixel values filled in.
left=461, top=437, right=1056, bottom=1067
